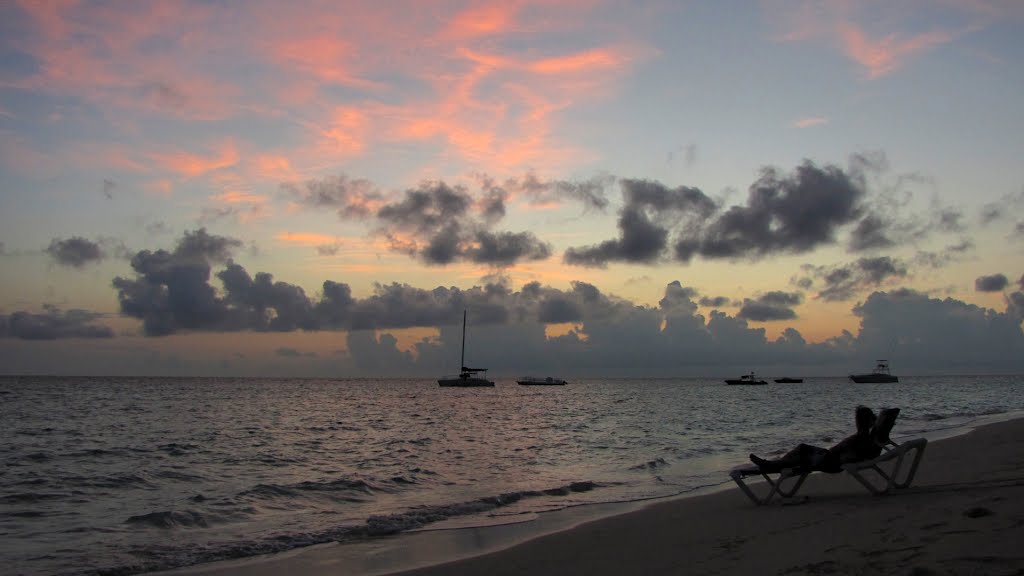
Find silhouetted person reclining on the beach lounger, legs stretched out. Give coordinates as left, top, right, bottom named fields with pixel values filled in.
left=751, top=406, right=882, bottom=474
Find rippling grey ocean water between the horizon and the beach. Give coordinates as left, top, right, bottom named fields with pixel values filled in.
left=0, top=376, right=1024, bottom=575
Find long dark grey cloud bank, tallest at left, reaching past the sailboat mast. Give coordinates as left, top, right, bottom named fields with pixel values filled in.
left=113, top=230, right=631, bottom=336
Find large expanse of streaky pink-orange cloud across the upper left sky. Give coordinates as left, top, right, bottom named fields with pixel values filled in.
left=8, top=0, right=654, bottom=186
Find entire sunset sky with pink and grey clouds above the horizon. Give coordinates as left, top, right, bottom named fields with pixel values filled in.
left=0, top=0, right=1024, bottom=378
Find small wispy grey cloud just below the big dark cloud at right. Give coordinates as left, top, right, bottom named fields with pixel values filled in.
left=795, top=256, right=907, bottom=301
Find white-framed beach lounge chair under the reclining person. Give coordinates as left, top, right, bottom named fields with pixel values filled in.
left=729, top=408, right=928, bottom=504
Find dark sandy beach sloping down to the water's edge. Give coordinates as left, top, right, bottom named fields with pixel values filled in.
left=172, top=419, right=1024, bottom=576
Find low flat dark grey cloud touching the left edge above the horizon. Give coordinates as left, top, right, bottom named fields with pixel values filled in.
left=0, top=304, right=114, bottom=340
